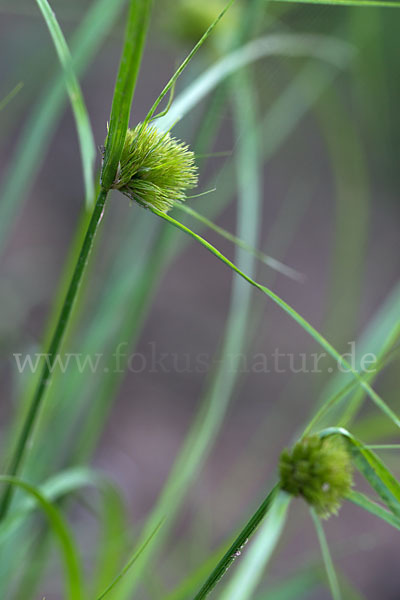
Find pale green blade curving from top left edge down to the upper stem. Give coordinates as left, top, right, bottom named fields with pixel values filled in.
left=36, top=0, right=96, bottom=207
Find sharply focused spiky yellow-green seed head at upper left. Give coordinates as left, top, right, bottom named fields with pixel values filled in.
left=113, top=123, right=197, bottom=212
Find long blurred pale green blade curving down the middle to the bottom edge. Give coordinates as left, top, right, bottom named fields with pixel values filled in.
left=112, top=61, right=261, bottom=600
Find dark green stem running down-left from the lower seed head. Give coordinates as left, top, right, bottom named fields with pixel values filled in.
left=194, top=485, right=279, bottom=600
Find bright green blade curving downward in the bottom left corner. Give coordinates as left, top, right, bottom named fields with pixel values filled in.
left=0, top=475, right=85, bottom=600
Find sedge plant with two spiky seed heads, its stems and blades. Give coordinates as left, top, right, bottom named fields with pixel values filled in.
left=0, top=0, right=400, bottom=600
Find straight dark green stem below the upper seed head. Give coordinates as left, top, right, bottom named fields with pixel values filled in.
left=0, top=188, right=108, bottom=521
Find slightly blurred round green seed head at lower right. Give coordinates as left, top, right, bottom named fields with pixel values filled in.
left=279, top=435, right=353, bottom=518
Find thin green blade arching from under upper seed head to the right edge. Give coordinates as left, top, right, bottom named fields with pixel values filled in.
left=151, top=208, right=400, bottom=428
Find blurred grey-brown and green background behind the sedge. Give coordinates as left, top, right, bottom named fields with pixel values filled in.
left=0, top=0, right=400, bottom=600
